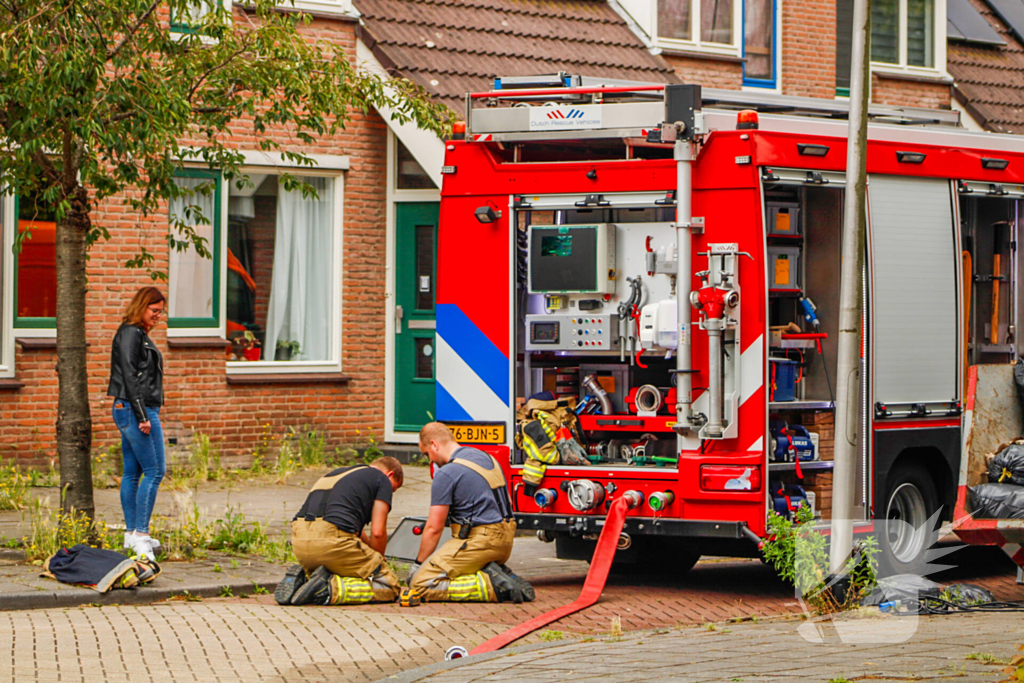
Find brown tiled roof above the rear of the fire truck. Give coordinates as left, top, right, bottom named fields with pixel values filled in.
left=355, top=0, right=678, bottom=112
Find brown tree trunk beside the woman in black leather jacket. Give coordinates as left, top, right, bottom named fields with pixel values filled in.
left=56, top=186, right=95, bottom=519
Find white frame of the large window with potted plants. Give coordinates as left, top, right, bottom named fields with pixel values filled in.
left=220, top=161, right=348, bottom=376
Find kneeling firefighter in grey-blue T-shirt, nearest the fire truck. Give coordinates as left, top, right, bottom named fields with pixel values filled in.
left=409, top=422, right=535, bottom=604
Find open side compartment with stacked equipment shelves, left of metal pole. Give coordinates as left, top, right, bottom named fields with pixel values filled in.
left=764, top=182, right=843, bottom=520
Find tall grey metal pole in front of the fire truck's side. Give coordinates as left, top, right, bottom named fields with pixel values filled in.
left=829, top=0, right=871, bottom=572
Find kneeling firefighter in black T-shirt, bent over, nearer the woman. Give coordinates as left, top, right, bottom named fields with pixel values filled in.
left=274, top=456, right=403, bottom=605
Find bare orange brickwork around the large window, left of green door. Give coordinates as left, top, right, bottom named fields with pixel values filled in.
left=0, top=18, right=386, bottom=465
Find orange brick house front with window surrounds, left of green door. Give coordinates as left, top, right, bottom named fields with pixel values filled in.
left=0, top=5, right=387, bottom=465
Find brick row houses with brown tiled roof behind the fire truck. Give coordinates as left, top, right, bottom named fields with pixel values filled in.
left=0, top=0, right=970, bottom=465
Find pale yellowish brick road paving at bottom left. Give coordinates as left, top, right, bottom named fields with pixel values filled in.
left=0, top=600, right=528, bottom=683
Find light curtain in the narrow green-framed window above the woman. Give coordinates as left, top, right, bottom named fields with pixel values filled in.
left=167, top=178, right=218, bottom=318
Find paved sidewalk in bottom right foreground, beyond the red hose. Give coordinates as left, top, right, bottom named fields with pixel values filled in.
left=380, top=612, right=1024, bottom=683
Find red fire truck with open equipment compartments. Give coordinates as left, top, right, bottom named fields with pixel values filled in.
left=436, top=74, right=1024, bottom=572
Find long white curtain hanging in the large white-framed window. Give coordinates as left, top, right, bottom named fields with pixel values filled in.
left=263, top=177, right=334, bottom=360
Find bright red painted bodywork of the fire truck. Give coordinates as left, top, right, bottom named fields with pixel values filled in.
left=438, top=116, right=1024, bottom=535
